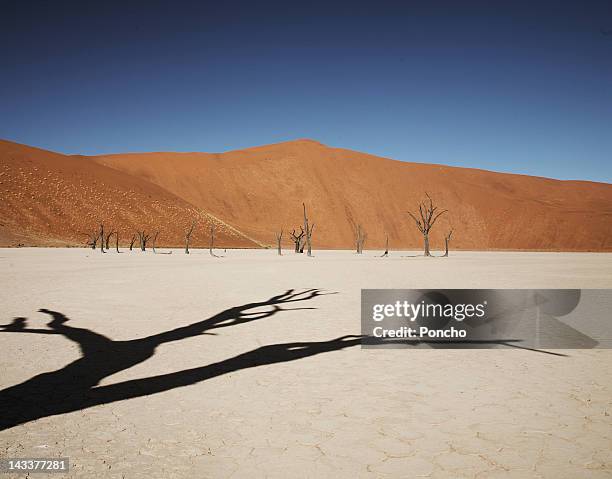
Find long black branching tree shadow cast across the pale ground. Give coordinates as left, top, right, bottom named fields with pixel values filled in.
left=0, top=289, right=361, bottom=430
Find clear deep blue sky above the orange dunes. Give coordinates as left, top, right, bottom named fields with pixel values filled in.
left=0, top=0, right=612, bottom=182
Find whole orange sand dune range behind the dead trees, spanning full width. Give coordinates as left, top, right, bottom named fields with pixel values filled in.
left=0, top=140, right=612, bottom=251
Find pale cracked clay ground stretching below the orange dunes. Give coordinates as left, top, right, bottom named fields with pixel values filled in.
left=0, top=248, right=612, bottom=479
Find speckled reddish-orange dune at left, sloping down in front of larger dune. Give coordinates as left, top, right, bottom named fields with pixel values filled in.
left=0, top=141, right=256, bottom=246
